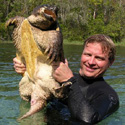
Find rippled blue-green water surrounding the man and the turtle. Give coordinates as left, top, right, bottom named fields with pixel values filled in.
left=0, top=43, right=125, bottom=125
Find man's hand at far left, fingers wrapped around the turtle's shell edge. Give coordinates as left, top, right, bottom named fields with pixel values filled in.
left=13, top=57, right=26, bottom=74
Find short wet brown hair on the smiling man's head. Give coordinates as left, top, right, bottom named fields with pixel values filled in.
left=83, top=34, right=116, bottom=62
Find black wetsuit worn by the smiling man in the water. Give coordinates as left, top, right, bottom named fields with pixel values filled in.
left=68, top=74, right=119, bottom=125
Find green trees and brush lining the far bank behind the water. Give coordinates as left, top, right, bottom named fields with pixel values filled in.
left=0, top=0, right=125, bottom=42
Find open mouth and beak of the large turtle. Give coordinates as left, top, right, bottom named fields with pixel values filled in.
left=43, top=9, right=57, bottom=21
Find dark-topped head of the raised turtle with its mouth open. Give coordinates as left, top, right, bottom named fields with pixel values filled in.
left=28, top=5, right=58, bottom=30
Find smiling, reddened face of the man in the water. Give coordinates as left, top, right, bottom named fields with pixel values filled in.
left=79, top=42, right=111, bottom=78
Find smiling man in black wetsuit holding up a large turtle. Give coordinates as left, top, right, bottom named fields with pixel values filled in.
left=14, top=34, right=119, bottom=124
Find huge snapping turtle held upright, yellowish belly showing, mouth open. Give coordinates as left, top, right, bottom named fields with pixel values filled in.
left=6, top=5, right=69, bottom=120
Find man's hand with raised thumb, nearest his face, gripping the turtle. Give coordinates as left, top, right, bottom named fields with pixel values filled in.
left=53, top=60, right=73, bottom=83
